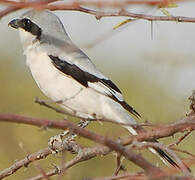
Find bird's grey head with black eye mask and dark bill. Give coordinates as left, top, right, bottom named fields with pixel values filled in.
left=8, top=10, right=69, bottom=49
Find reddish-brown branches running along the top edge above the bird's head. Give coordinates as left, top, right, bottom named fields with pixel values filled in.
left=0, top=0, right=195, bottom=23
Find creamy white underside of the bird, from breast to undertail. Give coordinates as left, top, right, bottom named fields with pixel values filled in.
left=25, top=46, right=135, bottom=123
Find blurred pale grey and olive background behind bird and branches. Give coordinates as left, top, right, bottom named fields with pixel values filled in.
left=0, top=2, right=195, bottom=180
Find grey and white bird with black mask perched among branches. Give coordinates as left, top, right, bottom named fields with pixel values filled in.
left=8, top=10, right=179, bottom=168
